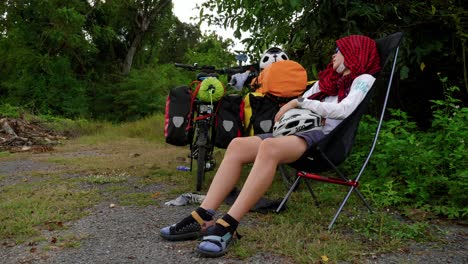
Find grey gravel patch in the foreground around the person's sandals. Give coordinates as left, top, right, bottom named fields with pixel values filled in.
left=0, top=203, right=292, bottom=264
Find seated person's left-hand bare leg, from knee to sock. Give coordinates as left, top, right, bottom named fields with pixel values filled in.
left=200, top=136, right=262, bottom=210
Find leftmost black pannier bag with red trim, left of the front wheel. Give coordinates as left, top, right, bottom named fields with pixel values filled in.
left=164, top=86, right=192, bottom=146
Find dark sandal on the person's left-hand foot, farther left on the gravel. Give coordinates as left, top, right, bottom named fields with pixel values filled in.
left=159, top=211, right=215, bottom=241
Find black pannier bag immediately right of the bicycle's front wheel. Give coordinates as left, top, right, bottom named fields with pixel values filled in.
left=214, top=94, right=244, bottom=148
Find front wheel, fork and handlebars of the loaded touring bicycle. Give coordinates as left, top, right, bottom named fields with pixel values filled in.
left=174, top=63, right=242, bottom=191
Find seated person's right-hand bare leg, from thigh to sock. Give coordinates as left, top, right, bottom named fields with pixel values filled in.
left=226, top=136, right=307, bottom=221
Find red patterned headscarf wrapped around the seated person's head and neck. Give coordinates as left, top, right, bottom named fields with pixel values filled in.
left=309, top=35, right=380, bottom=102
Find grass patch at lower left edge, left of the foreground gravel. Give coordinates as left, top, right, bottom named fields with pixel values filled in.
left=0, top=181, right=99, bottom=242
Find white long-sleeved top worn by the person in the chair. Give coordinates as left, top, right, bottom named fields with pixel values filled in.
left=298, top=74, right=375, bottom=134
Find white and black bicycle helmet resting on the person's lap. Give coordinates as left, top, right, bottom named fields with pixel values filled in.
left=273, top=108, right=322, bottom=137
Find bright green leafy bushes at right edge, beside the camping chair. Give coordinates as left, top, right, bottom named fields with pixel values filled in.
left=345, top=78, right=468, bottom=218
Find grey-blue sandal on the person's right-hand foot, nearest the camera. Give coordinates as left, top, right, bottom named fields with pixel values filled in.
left=195, top=219, right=241, bottom=258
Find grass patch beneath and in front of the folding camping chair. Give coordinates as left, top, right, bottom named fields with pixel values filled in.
left=231, top=186, right=429, bottom=263
